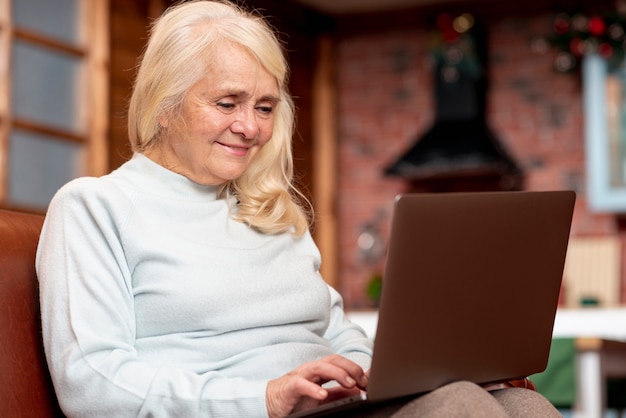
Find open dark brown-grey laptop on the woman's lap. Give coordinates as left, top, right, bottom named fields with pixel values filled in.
left=291, top=191, right=576, bottom=417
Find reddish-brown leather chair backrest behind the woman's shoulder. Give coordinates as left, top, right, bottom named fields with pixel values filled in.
left=0, top=210, right=63, bottom=418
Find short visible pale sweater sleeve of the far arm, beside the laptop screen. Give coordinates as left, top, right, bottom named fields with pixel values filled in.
left=324, top=286, right=373, bottom=370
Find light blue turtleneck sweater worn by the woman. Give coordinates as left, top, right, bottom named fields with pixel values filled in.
left=37, top=154, right=371, bottom=418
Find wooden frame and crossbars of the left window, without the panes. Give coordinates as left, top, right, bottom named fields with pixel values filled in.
left=0, top=0, right=110, bottom=213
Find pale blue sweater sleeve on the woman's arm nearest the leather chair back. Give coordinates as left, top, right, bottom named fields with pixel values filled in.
left=36, top=179, right=267, bottom=418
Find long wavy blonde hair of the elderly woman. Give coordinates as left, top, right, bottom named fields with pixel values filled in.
left=128, top=0, right=312, bottom=235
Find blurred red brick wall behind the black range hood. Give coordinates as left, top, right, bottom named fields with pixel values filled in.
left=337, top=15, right=624, bottom=309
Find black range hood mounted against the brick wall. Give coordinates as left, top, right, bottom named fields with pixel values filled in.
left=385, top=18, right=522, bottom=189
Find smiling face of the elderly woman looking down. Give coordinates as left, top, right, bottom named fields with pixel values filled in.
left=146, top=44, right=279, bottom=185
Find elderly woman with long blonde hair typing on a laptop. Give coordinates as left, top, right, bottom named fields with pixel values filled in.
left=37, top=1, right=551, bottom=418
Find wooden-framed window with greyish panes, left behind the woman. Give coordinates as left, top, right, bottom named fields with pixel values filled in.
left=0, top=0, right=108, bottom=212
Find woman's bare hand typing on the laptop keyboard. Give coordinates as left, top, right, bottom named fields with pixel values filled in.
left=265, top=355, right=368, bottom=418
